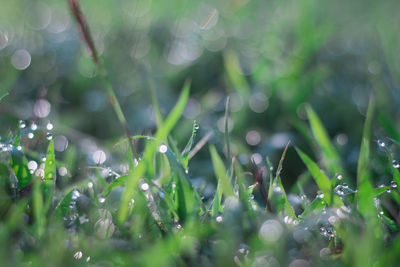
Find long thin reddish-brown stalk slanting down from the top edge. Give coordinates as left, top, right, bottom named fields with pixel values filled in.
left=68, top=0, right=137, bottom=158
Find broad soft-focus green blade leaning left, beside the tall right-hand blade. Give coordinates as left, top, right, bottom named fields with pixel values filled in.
left=306, top=105, right=345, bottom=178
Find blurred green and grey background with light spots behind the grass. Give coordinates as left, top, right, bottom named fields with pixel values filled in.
left=0, top=0, right=400, bottom=197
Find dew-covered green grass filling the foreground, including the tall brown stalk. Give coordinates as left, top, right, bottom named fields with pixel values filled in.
left=0, top=0, right=400, bottom=267
